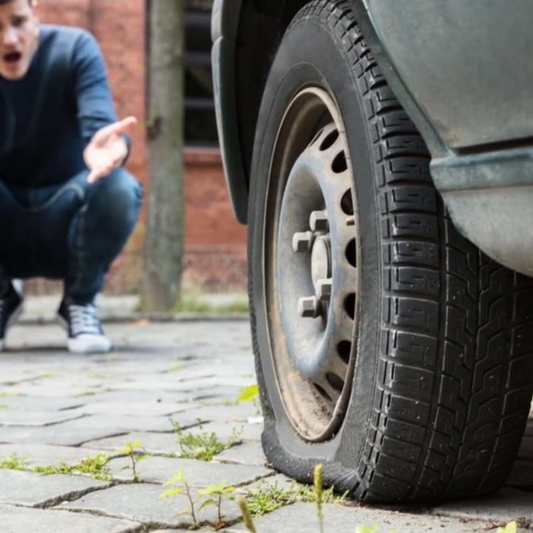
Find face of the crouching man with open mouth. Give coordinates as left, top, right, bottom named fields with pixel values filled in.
left=0, top=0, right=39, bottom=81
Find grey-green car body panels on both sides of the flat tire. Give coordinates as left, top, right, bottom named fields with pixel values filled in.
left=212, top=0, right=533, bottom=274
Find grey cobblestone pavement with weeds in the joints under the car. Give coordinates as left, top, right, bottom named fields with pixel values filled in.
left=0, top=320, right=533, bottom=533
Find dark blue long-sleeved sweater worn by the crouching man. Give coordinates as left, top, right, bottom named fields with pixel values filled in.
left=0, top=25, right=125, bottom=187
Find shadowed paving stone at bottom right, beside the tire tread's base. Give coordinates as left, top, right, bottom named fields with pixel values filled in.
left=433, top=489, right=533, bottom=523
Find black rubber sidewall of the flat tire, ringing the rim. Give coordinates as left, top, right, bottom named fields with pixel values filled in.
left=249, top=18, right=381, bottom=479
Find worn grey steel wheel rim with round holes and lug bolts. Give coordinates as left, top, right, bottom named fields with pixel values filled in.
left=264, top=88, right=361, bottom=442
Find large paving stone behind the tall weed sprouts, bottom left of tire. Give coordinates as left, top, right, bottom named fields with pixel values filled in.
left=60, top=483, right=240, bottom=528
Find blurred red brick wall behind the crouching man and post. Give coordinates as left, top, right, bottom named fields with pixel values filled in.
left=32, top=0, right=246, bottom=293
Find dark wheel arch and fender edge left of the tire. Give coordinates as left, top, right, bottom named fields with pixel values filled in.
left=212, top=0, right=372, bottom=224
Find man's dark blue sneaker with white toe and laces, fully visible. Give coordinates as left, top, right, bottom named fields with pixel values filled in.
left=57, top=299, right=113, bottom=354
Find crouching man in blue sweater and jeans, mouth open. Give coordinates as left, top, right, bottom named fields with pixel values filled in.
left=0, top=0, right=142, bottom=353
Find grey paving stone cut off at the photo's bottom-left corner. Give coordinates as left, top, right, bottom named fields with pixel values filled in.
left=0, top=505, right=140, bottom=533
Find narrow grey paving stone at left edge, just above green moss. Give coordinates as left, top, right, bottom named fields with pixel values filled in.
left=0, top=444, right=107, bottom=466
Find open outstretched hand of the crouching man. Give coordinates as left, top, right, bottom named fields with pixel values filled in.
left=83, top=117, right=137, bottom=183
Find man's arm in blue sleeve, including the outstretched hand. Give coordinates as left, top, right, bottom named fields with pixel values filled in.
left=74, top=33, right=137, bottom=183
